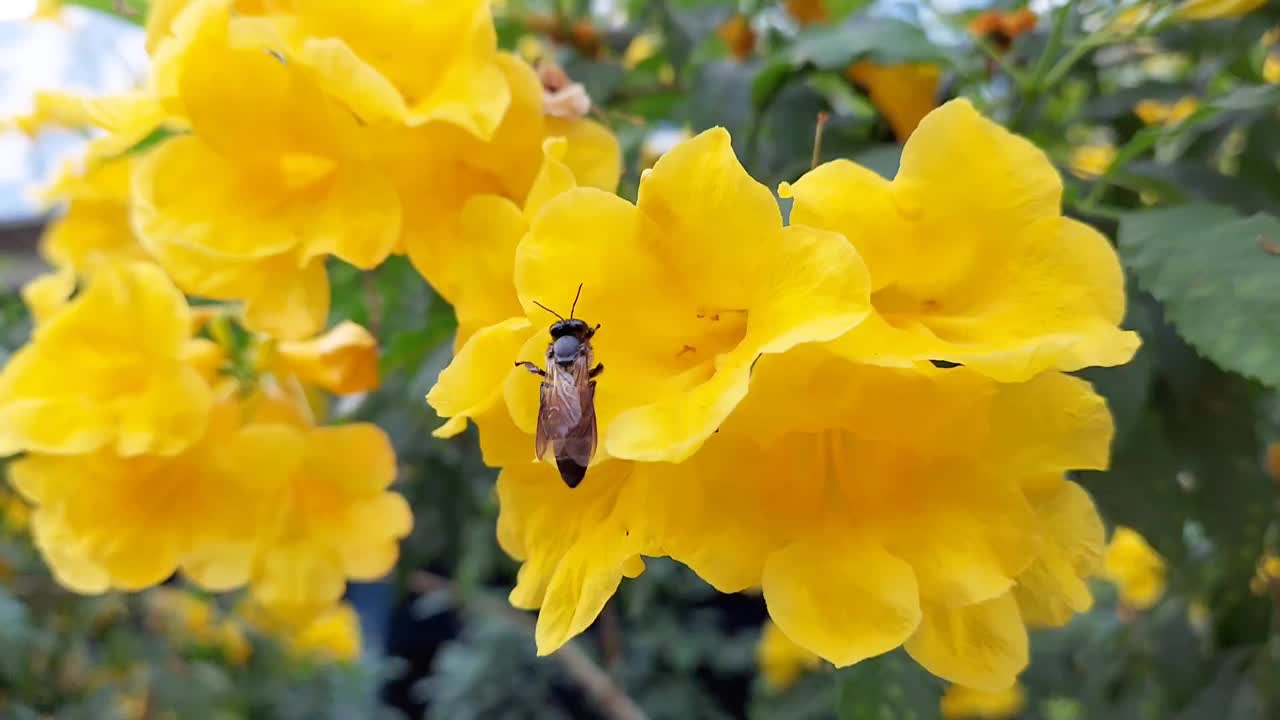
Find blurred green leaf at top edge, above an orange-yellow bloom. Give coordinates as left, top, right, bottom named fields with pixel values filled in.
left=791, top=18, right=945, bottom=70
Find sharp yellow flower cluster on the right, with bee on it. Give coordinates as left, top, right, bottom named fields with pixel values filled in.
left=428, top=79, right=1138, bottom=691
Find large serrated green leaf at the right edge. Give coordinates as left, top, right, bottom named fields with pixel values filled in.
left=1120, top=205, right=1280, bottom=387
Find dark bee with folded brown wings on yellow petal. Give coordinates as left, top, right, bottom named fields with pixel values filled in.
left=516, top=284, right=604, bottom=488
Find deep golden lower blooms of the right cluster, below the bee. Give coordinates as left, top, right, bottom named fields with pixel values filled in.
left=498, top=345, right=1111, bottom=691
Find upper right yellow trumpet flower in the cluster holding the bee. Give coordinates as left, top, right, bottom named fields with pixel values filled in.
left=782, top=100, right=1139, bottom=382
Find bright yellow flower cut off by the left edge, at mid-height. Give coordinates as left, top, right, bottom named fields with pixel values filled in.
left=0, top=263, right=211, bottom=456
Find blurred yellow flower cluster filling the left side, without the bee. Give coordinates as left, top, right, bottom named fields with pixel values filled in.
left=0, top=0, right=621, bottom=638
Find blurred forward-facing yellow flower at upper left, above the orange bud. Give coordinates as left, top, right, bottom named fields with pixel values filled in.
left=133, top=0, right=401, bottom=340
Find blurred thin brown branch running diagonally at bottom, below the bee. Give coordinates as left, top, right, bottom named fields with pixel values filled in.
left=408, top=570, right=649, bottom=720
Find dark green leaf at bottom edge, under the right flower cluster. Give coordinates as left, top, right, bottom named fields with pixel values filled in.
left=836, top=650, right=942, bottom=720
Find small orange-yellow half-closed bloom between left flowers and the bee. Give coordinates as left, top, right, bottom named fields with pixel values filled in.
left=271, top=322, right=378, bottom=395
